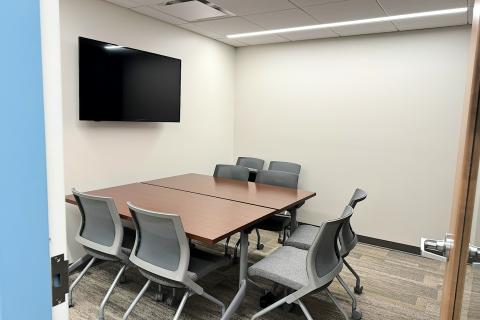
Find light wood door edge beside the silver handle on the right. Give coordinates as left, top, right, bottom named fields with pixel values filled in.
left=440, top=0, right=480, bottom=320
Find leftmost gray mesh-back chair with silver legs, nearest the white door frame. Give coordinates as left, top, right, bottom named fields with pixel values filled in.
left=69, top=189, right=130, bottom=319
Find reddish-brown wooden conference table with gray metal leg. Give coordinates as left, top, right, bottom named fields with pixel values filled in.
left=66, top=174, right=315, bottom=319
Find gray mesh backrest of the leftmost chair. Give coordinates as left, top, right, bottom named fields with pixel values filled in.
left=72, top=188, right=123, bottom=256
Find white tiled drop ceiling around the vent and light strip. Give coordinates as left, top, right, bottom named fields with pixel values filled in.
left=106, top=0, right=473, bottom=46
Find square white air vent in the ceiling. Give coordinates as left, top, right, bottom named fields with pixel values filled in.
left=160, top=0, right=233, bottom=21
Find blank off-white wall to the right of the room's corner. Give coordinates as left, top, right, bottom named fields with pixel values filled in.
left=234, top=27, right=469, bottom=246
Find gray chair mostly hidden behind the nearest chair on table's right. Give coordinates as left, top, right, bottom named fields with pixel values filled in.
left=285, top=188, right=367, bottom=294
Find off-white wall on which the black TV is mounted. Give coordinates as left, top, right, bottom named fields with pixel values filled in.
left=60, top=0, right=235, bottom=260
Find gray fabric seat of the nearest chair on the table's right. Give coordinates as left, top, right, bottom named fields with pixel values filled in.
left=248, top=247, right=308, bottom=290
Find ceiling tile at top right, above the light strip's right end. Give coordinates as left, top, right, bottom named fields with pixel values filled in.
left=378, top=0, right=467, bottom=15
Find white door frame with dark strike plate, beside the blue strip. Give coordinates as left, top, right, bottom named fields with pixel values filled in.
left=40, top=0, right=68, bottom=320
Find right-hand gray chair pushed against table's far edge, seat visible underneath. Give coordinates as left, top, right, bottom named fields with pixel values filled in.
left=251, top=170, right=298, bottom=250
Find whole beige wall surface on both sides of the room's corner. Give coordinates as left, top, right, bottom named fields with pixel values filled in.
left=60, top=0, right=469, bottom=252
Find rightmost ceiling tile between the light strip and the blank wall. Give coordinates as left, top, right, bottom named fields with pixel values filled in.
left=392, top=12, right=468, bottom=30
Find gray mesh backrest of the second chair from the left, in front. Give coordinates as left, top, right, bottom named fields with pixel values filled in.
left=127, top=202, right=190, bottom=282
